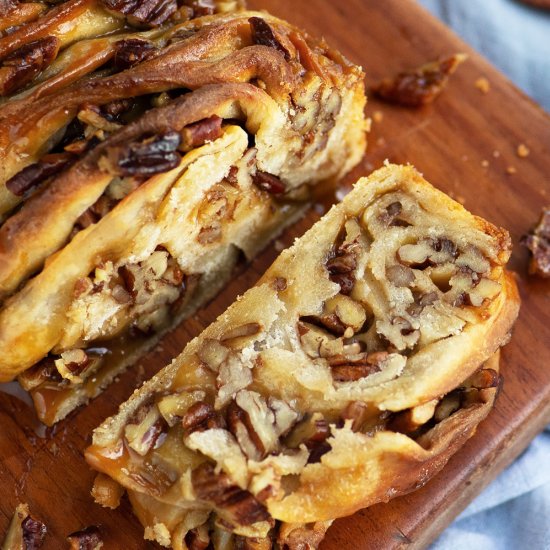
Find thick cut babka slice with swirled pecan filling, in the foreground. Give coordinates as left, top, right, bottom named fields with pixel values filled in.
left=86, top=165, right=519, bottom=549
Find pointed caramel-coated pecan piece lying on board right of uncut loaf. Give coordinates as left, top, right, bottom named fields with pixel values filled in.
left=373, top=54, right=466, bottom=107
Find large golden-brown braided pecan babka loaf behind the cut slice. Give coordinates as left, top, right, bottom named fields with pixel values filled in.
left=0, top=6, right=366, bottom=424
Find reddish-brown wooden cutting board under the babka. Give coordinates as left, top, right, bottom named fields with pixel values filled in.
left=0, top=0, right=550, bottom=550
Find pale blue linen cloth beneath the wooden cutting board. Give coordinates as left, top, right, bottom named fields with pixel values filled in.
left=418, top=0, right=550, bottom=550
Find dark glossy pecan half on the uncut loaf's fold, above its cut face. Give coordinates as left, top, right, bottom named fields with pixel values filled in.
left=103, top=131, right=181, bottom=177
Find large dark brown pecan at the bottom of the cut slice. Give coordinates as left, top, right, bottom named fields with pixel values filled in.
left=191, top=462, right=271, bottom=525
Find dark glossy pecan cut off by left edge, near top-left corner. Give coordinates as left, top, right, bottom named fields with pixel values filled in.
left=0, top=36, right=61, bottom=96
